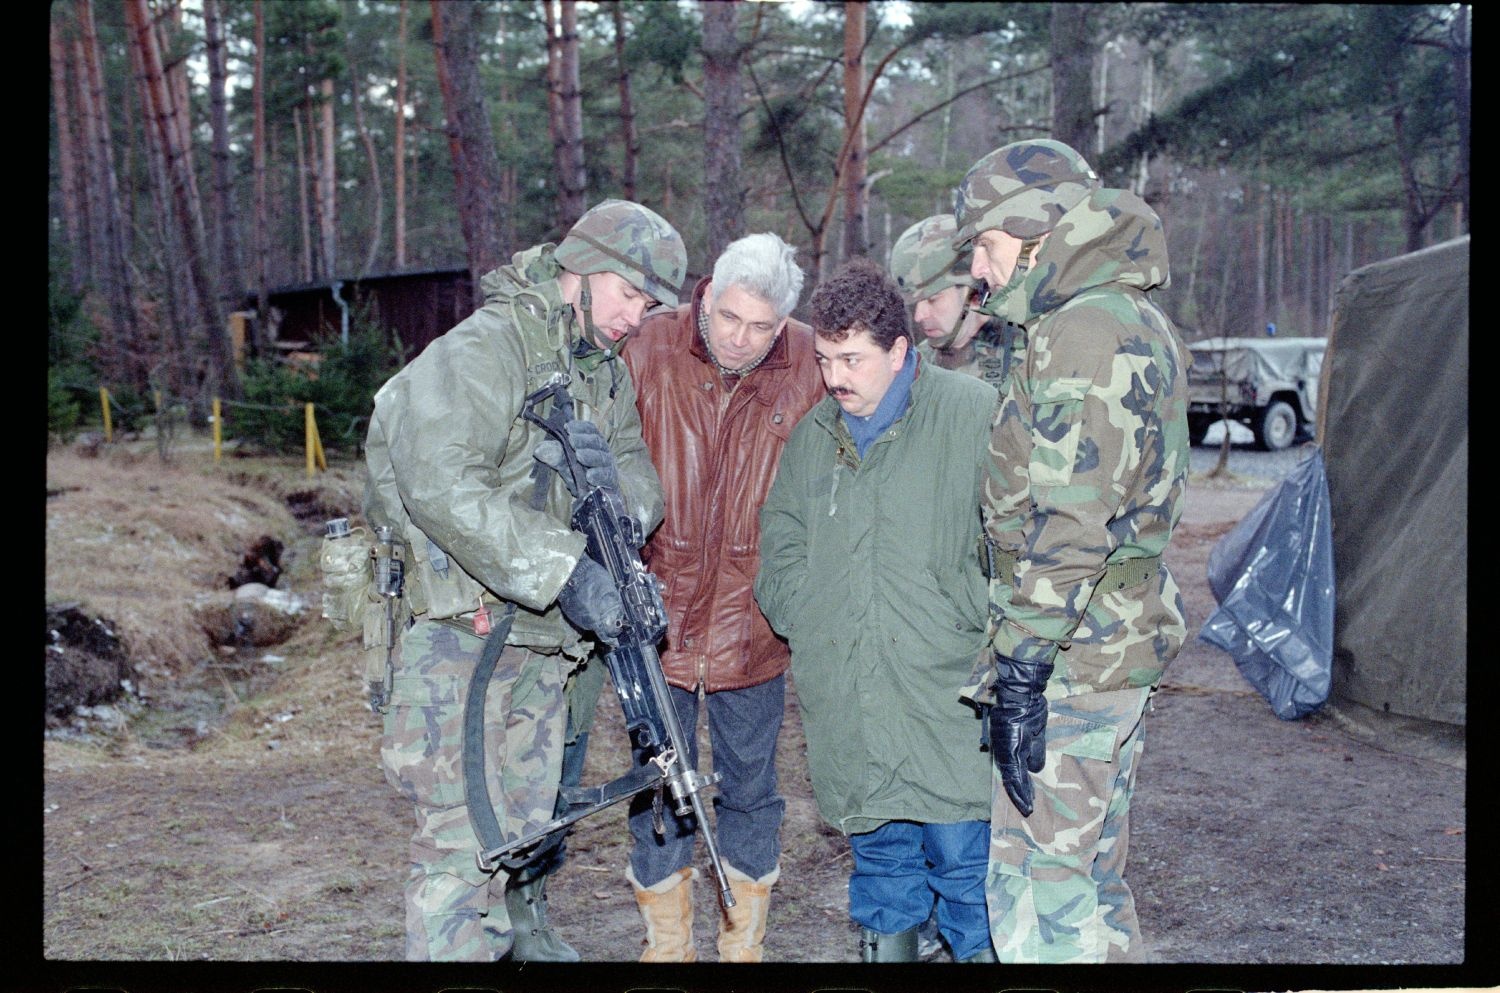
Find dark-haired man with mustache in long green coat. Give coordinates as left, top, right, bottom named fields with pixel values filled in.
left=756, top=258, right=998, bottom=962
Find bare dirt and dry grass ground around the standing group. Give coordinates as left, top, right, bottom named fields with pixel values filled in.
left=38, top=446, right=1476, bottom=993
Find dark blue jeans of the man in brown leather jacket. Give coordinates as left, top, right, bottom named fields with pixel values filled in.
left=630, top=675, right=786, bottom=888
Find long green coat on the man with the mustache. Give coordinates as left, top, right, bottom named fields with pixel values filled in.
left=755, top=362, right=998, bottom=834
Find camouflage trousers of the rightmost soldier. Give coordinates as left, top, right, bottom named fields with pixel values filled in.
left=986, top=689, right=1151, bottom=965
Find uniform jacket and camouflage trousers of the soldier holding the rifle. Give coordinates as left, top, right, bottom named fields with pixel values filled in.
left=365, top=228, right=675, bottom=962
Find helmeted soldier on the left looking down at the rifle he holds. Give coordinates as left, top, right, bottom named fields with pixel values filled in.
left=365, top=200, right=687, bottom=962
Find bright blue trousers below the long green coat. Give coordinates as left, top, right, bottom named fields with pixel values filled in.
left=849, top=821, right=990, bottom=960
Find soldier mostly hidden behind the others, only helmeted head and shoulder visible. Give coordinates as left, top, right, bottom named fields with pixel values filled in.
left=890, top=215, right=1023, bottom=396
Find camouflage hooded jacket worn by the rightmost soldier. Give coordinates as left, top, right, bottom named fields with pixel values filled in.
left=969, top=189, right=1188, bottom=701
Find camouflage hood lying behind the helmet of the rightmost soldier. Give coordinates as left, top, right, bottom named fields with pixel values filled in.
left=1019, top=189, right=1169, bottom=324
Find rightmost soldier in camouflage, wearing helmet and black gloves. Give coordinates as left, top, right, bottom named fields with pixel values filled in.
left=954, top=141, right=1188, bottom=963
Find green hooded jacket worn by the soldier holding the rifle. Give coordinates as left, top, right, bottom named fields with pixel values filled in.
left=365, top=245, right=662, bottom=654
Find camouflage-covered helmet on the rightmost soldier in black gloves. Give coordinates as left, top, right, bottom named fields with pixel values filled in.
left=953, top=138, right=1100, bottom=249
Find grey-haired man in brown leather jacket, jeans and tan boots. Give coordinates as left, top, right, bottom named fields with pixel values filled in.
left=623, top=234, right=824, bottom=962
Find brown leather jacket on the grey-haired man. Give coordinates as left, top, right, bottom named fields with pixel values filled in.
left=621, top=279, right=825, bottom=693
